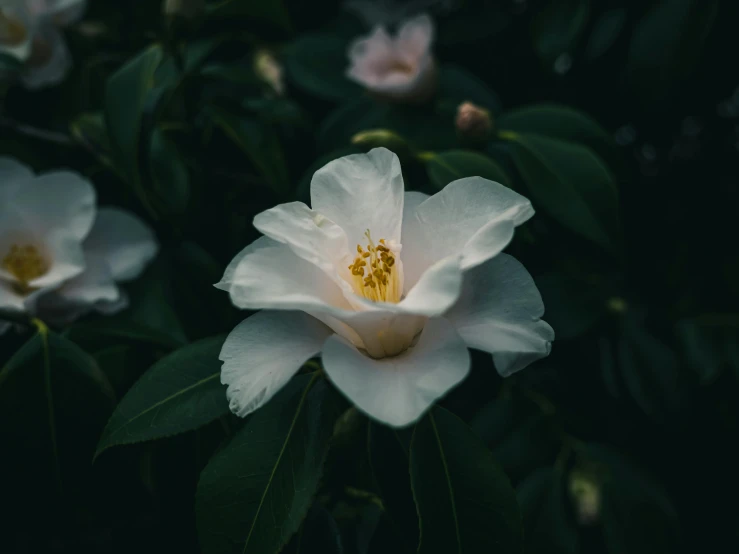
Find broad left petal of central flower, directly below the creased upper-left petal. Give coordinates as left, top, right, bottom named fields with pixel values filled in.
left=216, top=237, right=350, bottom=310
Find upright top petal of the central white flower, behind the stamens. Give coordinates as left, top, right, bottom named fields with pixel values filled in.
left=311, top=148, right=403, bottom=248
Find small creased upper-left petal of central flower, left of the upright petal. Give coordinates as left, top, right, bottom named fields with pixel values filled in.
left=254, top=202, right=349, bottom=273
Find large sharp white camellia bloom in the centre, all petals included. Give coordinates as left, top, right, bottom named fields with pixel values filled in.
left=216, top=148, right=554, bottom=426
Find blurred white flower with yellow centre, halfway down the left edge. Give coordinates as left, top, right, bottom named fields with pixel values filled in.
left=0, top=158, right=157, bottom=332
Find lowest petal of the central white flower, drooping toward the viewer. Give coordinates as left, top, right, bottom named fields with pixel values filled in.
left=322, top=319, right=470, bottom=427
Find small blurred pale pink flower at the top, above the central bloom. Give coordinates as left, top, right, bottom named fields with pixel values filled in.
left=347, top=15, right=436, bottom=102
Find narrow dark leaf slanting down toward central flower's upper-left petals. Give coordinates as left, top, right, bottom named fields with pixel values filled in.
left=209, top=106, right=289, bottom=195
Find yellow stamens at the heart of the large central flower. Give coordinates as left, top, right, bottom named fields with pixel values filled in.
left=349, top=229, right=402, bottom=304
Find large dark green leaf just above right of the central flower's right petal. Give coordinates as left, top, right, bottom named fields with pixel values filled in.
left=501, top=133, right=622, bottom=255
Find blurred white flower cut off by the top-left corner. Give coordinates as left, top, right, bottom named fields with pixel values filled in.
left=0, top=0, right=87, bottom=89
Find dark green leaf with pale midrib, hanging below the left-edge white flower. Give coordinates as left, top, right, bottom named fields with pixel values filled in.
left=0, top=323, right=115, bottom=492
